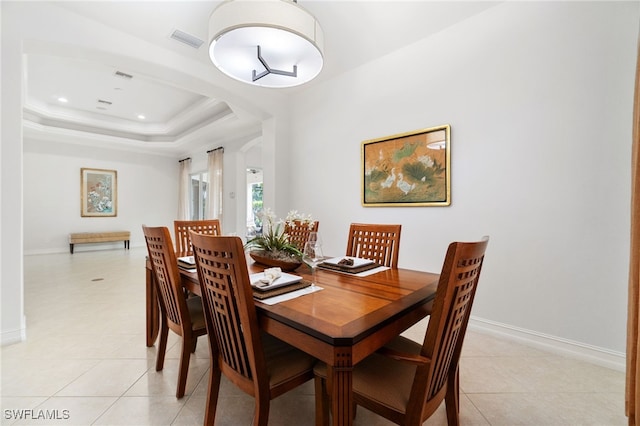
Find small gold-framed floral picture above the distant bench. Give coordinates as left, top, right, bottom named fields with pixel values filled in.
left=80, top=167, right=118, bottom=217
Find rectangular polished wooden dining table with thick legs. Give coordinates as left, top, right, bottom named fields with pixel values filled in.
left=147, top=260, right=439, bottom=425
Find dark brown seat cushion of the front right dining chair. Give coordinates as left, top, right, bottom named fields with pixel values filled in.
left=314, top=336, right=421, bottom=412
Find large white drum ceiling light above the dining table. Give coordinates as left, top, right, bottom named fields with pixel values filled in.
left=209, top=0, right=324, bottom=87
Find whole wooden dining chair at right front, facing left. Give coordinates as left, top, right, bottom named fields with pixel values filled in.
left=314, top=237, right=489, bottom=426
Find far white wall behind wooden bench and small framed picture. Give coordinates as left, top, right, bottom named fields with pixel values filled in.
left=24, top=140, right=179, bottom=254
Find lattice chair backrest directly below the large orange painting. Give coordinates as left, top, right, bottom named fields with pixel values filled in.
left=346, top=223, right=402, bottom=268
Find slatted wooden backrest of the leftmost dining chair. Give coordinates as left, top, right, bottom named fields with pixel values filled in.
left=142, top=225, right=191, bottom=335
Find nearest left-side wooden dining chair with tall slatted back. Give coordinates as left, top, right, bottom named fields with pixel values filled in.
left=191, top=232, right=315, bottom=425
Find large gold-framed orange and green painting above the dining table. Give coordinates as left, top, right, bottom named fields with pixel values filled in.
left=361, top=124, right=451, bottom=207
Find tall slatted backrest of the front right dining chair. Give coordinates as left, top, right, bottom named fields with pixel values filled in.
left=407, top=237, right=489, bottom=418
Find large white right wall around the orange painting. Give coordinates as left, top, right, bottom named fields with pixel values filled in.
left=289, top=2, right=639, bottom=354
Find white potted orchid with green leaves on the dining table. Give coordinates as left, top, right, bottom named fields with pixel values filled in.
left=245, top=208, right=314, bottom=270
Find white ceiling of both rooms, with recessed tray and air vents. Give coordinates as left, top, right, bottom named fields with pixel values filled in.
left=24, top=0, right=497, bottom=155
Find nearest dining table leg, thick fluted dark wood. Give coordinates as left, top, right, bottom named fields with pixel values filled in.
left=327, top=348, right=353, bottom=426
